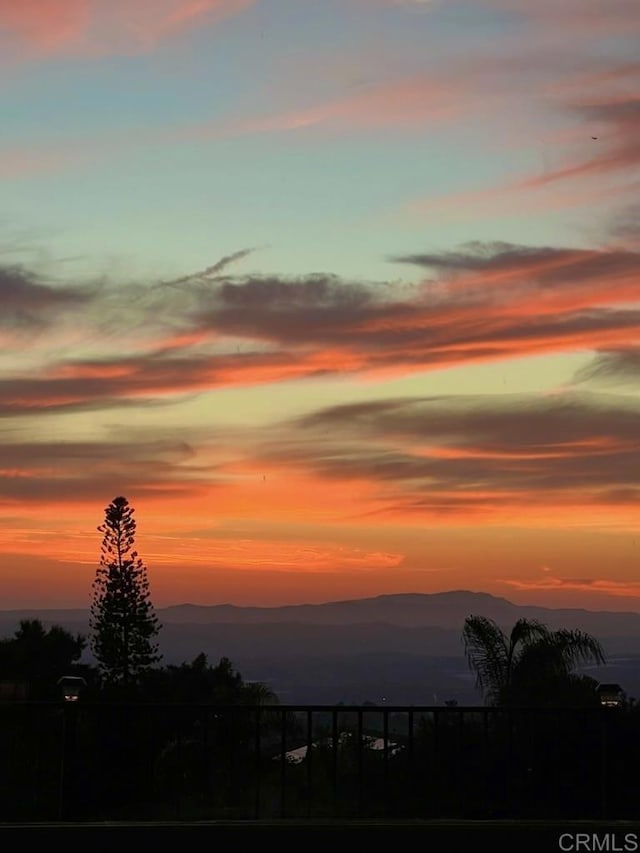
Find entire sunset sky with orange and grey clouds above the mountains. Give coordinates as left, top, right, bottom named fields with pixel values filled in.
left=0, top=0, right=640, bottom=611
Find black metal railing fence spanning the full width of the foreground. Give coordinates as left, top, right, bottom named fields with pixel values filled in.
left=0, top=702, right=640, bottom=822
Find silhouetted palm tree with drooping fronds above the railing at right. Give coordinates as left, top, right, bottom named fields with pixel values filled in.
left=462, top=616, right=605, bottom=705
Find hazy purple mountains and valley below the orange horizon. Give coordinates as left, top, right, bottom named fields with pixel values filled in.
left=0, top=591, right=640, bottom=704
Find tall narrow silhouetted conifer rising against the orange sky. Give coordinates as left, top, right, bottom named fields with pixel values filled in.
left=90, top=497, right=161, bottom=684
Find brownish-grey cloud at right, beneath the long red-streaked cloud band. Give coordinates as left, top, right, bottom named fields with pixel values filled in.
left=256, top=393, right=640, bottom=525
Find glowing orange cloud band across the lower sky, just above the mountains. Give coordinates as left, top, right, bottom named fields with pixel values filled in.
left=0, top=422, right=639, bottom=606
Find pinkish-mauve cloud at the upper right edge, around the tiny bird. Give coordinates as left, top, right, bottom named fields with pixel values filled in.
left=406, top=62, right=640, bottom=217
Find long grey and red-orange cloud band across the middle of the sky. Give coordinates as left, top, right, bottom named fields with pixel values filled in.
left=0, top=238, right=640, bottom=416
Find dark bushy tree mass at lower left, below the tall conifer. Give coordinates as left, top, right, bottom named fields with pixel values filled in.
left=0, top=620, right=278, bottom=821
